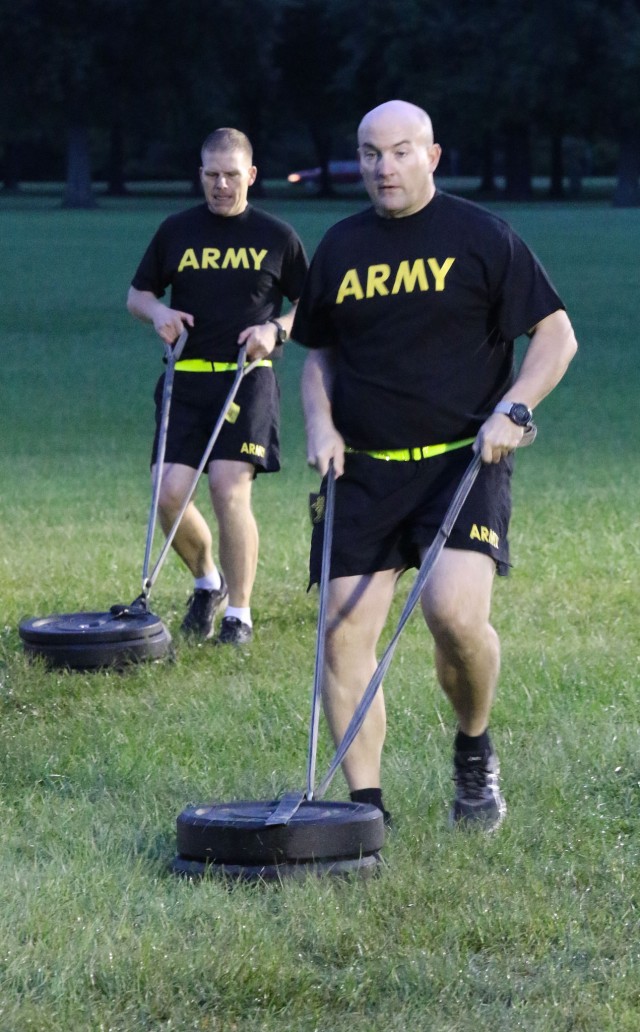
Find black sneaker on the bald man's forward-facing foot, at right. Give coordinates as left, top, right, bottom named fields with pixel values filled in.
left=451, top=750, right=507, bottom=832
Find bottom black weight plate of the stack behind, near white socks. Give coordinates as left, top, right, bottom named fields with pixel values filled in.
left=24, top=627, right=171, bottom=670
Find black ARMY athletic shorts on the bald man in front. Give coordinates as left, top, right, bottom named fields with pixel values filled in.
left=310, top=445, right=513, bottom=584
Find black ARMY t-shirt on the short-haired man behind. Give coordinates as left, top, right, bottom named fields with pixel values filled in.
left=132, top=203, right=307, bottom=362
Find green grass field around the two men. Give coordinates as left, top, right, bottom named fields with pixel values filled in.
left=0, top=187, right=640, bottom=1032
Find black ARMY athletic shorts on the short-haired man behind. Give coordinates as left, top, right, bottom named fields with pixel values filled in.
left=151, top=366, right=280, bottom=473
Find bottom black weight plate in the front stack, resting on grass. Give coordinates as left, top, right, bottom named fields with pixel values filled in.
left=171, top=852, right=382, bottom=881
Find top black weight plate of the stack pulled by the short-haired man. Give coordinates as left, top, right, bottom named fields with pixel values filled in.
left=18, top=612, right=164, bottom=645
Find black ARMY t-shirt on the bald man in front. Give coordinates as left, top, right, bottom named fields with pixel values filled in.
left=291, top=191, right=564, bottom=450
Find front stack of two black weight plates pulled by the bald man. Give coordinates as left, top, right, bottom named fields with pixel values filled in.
left=172, top=800, right=384, bottom=881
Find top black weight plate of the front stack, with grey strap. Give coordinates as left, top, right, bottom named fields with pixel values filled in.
left=178, top=800, right=384, bottom=866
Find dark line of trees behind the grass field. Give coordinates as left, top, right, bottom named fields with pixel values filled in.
left=0, top=0, right=640, bottom=206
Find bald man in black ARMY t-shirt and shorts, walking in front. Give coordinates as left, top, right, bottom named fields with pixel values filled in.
left=291, top=100, right=577, bottom=831
